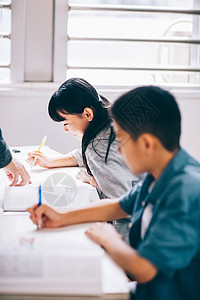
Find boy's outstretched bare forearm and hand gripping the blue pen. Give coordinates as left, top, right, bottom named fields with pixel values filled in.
left=27, top=199, right=128, bottom=228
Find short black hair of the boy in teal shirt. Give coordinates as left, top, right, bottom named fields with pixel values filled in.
left=111, top=86, right=181, bottom=151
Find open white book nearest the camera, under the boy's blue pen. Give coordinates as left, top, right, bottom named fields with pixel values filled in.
left=0, top=216, right=104, bottom=294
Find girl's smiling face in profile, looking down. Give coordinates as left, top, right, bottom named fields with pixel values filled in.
left=59, top=109, right=93, bottom=140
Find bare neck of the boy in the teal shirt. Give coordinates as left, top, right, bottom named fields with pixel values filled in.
left=150, top=147, right=180, bottom=179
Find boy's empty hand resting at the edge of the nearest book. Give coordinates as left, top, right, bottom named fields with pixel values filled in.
left=85, top=223, right=122, bottom=249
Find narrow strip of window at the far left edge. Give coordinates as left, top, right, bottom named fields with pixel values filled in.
left=0, top=0, right=11, bottom=82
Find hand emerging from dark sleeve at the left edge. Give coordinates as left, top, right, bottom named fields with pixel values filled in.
left=3, top=158, right=31, bottom=186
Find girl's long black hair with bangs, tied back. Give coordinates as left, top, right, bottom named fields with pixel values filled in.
left=48, top=78, right=115, bottom=175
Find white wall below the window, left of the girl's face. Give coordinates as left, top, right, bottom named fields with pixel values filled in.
left=0, top=86, right=80, bottom=153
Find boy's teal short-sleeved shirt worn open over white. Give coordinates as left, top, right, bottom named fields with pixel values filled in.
left=120, top=149, right=200, bottom=300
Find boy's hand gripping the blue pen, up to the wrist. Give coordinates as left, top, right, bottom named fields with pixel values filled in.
left=26, top=204, right=62, bottom=228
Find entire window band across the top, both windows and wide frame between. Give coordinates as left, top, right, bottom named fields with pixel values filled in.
left=0, top=0, right=200, bottom=88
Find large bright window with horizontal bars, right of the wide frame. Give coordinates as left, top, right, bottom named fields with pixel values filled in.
left=67, top=0, right=200, bottom=86
